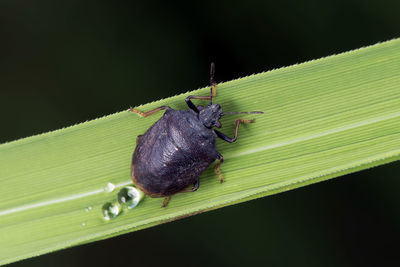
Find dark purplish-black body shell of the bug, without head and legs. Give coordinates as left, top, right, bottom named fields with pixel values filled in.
left=131, top=108, right=218, bottom=197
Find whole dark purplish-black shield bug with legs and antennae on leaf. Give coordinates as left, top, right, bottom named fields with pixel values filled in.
left=130, top=63, right=263, bottom=207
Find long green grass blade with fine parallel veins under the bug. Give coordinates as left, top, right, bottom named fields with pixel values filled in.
left=0, top=39, right=400, bottom=264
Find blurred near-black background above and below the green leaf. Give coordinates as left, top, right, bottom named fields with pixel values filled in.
left=0, top=0, right=400, bottom=267
